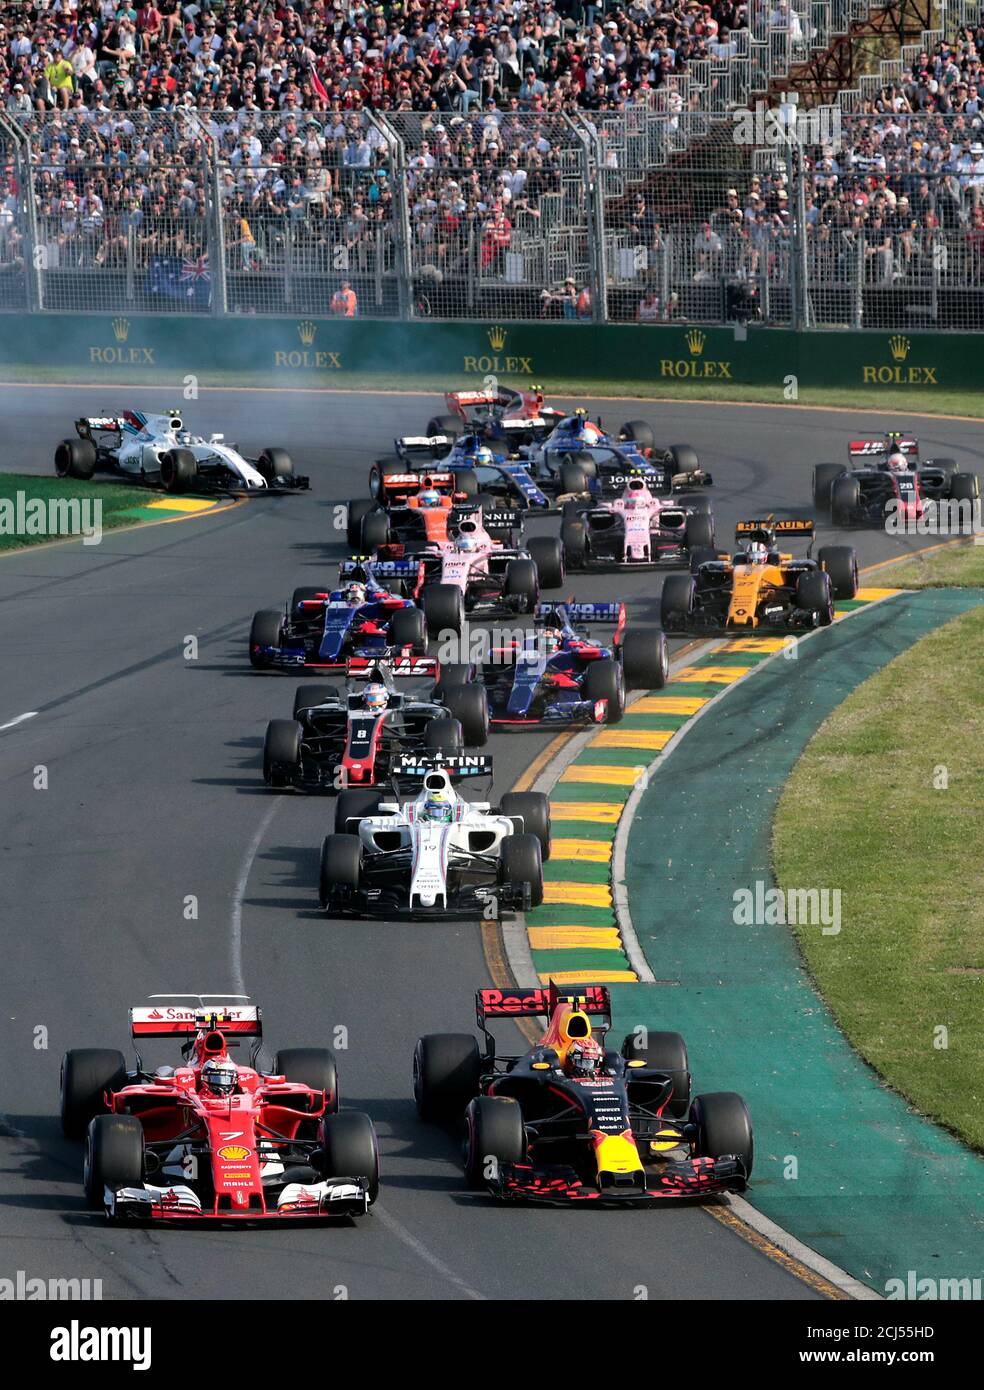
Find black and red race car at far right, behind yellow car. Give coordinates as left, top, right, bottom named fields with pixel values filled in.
left=813, top=432, right=980, bottom=530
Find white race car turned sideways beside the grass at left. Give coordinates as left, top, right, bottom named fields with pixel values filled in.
left=54, top=410, right=310, bottom=493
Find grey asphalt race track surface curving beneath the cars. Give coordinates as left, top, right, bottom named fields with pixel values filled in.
left=0, top=386, right=981, bottom=1300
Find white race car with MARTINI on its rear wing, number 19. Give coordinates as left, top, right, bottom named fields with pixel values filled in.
left=320, top=753, right=550, bottom=917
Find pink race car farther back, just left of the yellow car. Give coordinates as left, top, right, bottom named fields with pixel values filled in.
left=560, top=475, right=714, bottom=570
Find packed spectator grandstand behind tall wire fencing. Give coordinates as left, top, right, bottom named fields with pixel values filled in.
left=0, top=0, right=984, bottom=329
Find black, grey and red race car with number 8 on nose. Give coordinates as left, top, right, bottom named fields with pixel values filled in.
left=263, top=662, right=489, bottom=791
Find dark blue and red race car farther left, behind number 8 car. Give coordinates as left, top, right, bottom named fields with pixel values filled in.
left=249, top=575, right=436, bottom=676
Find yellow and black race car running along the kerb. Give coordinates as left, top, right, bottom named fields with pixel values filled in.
left=660, top=517, right=858, bottom=632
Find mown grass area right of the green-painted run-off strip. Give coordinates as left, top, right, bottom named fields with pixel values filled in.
left=773, top=608, right=984, bottom=1150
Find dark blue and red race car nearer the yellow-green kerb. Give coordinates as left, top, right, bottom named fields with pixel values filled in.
left=441, top=600, right=667, bottom=727
